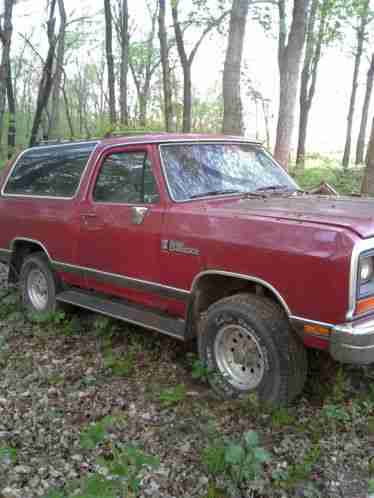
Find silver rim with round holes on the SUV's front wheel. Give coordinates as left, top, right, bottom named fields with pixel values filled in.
left=214, top=324, right=265, bottom=391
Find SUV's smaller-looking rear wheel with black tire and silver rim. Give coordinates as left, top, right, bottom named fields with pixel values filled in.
left=20, top=252, right=61, bottom=315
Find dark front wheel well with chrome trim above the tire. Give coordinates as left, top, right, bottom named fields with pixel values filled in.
left=187, top=270, right=291, bottom=338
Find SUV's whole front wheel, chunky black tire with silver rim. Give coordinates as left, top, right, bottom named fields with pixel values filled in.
left=198, top=294, right=308, bottom=405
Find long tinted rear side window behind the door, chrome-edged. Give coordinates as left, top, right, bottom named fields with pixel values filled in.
left=4, top=142, right=96, bottom=197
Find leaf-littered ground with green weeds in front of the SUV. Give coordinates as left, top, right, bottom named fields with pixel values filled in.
left=0, top=267, right=374, bottom=498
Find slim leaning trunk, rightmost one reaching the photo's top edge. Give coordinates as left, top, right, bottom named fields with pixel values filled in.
left=342, top=0, right=369, bottom=168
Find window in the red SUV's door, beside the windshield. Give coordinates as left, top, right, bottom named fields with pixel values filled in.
left=93, top=152, right=159, bottom=204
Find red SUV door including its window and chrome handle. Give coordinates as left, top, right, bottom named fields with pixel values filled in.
left=79, top=146, right=164, bottom=306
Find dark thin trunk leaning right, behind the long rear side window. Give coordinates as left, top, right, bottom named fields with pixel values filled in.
left=30, top=0, right=57, bottom=147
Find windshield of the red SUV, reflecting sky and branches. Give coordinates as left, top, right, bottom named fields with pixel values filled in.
left=161, top=143, right=298, bottom=201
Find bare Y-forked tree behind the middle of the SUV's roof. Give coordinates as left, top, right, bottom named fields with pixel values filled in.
left=171, top=0, right=229, bottom=133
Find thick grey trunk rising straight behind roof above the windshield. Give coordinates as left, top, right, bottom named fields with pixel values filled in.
left=223, top=0, right=249, bottom=135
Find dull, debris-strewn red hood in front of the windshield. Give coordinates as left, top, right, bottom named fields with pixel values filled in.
left=210, top=194, right=374, bottom=238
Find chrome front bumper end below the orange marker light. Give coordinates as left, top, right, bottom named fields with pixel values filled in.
left=330, top=318, right=374, bottom=365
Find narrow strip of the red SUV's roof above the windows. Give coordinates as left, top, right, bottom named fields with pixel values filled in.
left=33, top=132, right=261, bottom=149
